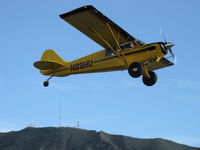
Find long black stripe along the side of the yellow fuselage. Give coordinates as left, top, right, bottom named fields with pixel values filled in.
left=94, top=46, right=156, bottom=63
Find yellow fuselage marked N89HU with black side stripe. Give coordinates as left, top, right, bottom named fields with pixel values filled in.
left=41, top=42, right=165, bottom=77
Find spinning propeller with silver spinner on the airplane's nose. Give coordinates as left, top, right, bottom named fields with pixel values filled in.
left=160, top=29, right=176, bottom=63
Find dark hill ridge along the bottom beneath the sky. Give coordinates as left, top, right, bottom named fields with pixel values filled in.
left=0, top=127, right=200, bottom=150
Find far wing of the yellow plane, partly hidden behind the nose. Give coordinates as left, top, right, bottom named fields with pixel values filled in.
left=147, top=57, right=174, bottom=70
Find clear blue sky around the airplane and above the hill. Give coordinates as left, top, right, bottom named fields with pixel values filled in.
left=0, top=0, right=200, bottom=147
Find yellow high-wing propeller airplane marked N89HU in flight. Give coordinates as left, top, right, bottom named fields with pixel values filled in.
left=34, top=5, right=175, bottom=87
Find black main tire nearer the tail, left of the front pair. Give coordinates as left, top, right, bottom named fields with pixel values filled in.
left=128, top=62, right=142, bottom=78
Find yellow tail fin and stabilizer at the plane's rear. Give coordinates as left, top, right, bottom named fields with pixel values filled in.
left=34, top=49, right=67, bottom=70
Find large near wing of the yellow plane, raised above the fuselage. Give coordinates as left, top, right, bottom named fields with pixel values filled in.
left=60, top=5, right=144, bottom=49
